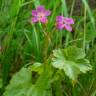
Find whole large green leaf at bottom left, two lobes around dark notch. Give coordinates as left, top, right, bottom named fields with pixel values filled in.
left=3, top=68, right=51, bottom=96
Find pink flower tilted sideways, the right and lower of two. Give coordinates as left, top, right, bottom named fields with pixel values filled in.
left=56, top=16, right=74, bottom=31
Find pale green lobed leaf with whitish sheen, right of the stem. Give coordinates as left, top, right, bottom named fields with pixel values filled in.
left=52, top=46, right=92, bottom=80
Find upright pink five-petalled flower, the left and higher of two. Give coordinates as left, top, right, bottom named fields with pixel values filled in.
left=32, top=6, right=51, bottom=23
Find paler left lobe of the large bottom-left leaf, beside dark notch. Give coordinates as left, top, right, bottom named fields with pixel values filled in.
left=3, top=68, right=32, bottom=96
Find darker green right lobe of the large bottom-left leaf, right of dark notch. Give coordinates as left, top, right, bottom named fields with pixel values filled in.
left=28, top=72, right=51, bottom=96
